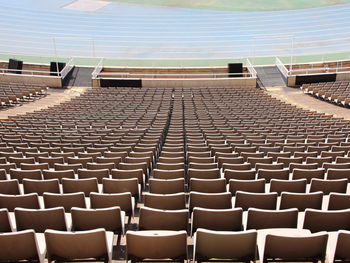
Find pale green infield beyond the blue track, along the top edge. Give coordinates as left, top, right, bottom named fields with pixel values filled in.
left=111, top=0, right=350, bottom=11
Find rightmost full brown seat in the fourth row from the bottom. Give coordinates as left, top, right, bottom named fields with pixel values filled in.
left=310, top=178, right=348, bottom=195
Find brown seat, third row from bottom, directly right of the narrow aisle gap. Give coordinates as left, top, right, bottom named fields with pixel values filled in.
left=144, top=193, right=186, bottom=210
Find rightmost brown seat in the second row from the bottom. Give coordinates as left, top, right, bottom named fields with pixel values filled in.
left=303, top=209, right=350, bottom=233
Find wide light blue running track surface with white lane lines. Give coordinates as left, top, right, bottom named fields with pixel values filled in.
left=0, top=0, right=350, bottom=63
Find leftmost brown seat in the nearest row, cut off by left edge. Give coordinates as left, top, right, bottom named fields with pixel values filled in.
left=0, top=229, right=46, bottom=263
